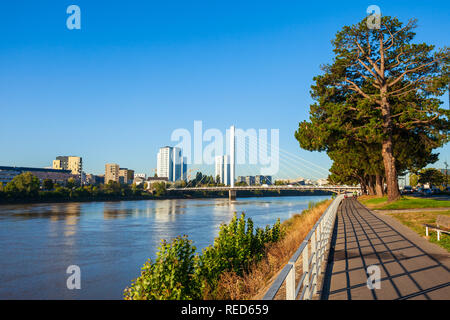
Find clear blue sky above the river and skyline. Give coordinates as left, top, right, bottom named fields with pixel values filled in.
left=0, top=0, right=450, bottom=177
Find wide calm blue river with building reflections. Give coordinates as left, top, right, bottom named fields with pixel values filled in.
left=0, top=196, right=329, bottom=299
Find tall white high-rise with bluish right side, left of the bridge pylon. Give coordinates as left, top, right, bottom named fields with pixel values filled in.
left=156, top=146, right=187, bottom=182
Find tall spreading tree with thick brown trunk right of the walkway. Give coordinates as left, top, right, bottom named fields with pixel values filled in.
left=295, top=17, right=450, bottom=200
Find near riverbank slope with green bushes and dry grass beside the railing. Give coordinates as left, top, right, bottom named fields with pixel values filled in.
left=124, top=200, right=332, bottom=300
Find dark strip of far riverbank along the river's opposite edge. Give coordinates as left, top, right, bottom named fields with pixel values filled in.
left=0, top=190, right=332, bottom=206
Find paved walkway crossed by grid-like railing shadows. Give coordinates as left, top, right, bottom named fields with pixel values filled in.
left=320, top=199, right=450, bottom=300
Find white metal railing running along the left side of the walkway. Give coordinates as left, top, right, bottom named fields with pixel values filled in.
left=263, top=195, right=344, bottom=300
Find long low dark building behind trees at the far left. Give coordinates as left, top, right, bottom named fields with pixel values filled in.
left=0, top=166, right=73, bottom=185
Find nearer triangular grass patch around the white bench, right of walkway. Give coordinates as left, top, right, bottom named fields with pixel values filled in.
left=388, top=210, right=450, bottom=252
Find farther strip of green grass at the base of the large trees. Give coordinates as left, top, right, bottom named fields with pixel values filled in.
left=358, top=196, right=450, bottom=210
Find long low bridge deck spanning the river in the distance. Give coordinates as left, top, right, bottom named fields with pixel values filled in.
left=167, top=185, right=361, bottom=200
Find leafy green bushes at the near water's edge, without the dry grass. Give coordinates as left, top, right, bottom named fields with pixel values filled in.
left=124, top=213, right=283, bottom=300
